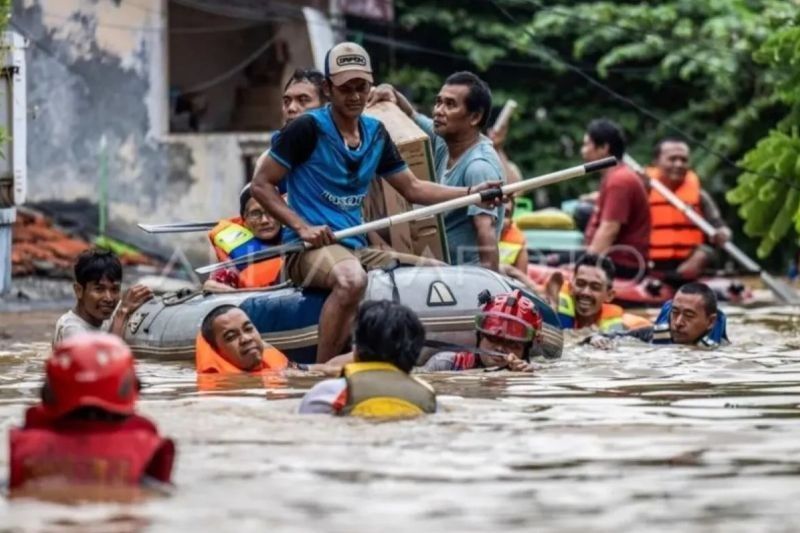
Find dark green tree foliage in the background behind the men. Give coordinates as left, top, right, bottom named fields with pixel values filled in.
left=351, top=0, right=800, bottom=262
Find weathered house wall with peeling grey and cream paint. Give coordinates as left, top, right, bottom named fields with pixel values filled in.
left=13, top=0, right=318, bottom=262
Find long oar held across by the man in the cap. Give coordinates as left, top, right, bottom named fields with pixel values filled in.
left=195, top=157, right=617, bottom=274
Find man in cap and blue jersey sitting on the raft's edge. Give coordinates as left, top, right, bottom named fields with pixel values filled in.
left=252, top=43, right=499, bottom=363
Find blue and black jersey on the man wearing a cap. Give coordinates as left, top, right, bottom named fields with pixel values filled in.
left=269, top=105, right=408, bottom=249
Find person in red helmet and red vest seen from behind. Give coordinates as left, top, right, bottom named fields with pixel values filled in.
left=9, top=333, right=175, bottom=496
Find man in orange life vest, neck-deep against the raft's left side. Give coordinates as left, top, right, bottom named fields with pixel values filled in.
left=195, top=305, right=289, bottom=374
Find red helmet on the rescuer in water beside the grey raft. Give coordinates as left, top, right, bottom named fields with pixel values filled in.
left=475, top=289, right=542, bottom=343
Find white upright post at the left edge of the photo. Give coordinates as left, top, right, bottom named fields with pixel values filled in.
left=0, top=31, right=28, bottom=294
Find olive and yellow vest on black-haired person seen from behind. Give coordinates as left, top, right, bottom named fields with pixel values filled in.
left=340, top=362, right=436, bottom=418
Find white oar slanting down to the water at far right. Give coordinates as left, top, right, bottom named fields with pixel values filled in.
left=623, top=154, right=800, bottom=305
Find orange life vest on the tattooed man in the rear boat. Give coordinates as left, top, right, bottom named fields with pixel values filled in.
left=647, top=167, right=705, bottom=261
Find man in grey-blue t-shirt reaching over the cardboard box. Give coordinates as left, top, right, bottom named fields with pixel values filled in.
left=369, top=72, right=505, bottom=271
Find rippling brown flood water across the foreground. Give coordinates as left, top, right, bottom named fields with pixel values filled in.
left=0, top=307, right=800, bottom=532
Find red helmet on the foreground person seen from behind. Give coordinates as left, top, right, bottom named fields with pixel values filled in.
left=42, top=333, right=139, bottom=418
